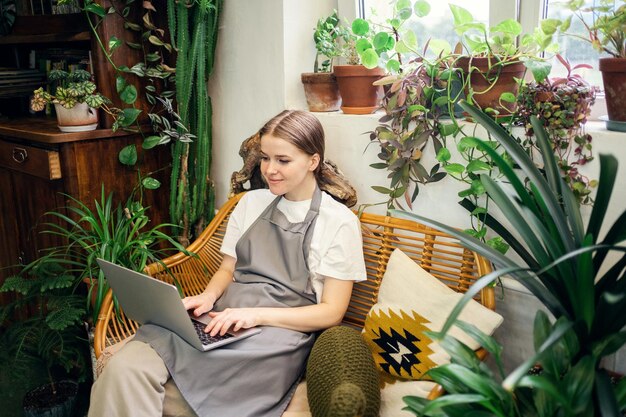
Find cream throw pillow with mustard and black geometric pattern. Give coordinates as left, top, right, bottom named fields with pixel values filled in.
left=363, top=249, right=502, bottom=379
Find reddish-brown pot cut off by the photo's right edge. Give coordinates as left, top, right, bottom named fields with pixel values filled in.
left=599, top=58, right=626, bottom=122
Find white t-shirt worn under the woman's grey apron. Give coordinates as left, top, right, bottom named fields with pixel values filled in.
left=221, top=189, right=367, bottom=303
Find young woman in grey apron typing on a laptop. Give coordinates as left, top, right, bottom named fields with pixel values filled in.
left=89, top=111, right=365, bottom=417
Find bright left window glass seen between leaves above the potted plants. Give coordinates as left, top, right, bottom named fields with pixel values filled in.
left=363, top=0, right=489, bottom=56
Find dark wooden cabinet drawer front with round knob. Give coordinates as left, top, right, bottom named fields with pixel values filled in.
left=0, top=140, right=61, bottom=180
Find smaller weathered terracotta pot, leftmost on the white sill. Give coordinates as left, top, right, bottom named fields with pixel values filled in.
left=300, top=72, right=341, bottom=112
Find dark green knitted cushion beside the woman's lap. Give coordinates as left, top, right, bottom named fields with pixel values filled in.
left=306, top=326, right=380, bottom=417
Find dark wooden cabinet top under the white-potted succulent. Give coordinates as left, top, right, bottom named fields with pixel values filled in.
left=0, top=117, right=133, bottom=144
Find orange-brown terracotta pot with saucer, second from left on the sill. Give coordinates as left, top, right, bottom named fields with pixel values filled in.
left=333, top=65, right=385, bottom=114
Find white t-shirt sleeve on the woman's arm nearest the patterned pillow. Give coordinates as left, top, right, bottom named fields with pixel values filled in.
left=316, top=216, right=367, bottom=281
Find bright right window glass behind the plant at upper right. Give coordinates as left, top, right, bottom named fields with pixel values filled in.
left=545, top=0, right=608, bottom=87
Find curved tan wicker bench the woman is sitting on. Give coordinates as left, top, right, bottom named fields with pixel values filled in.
left=94, top=194, right=495, bottom=406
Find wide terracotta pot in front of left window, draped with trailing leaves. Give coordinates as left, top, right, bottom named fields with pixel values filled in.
left=456, top=57, right=526, bottom=116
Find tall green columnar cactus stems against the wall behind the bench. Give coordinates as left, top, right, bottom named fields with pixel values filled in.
left=168, top=0, right=222, bottom=246
